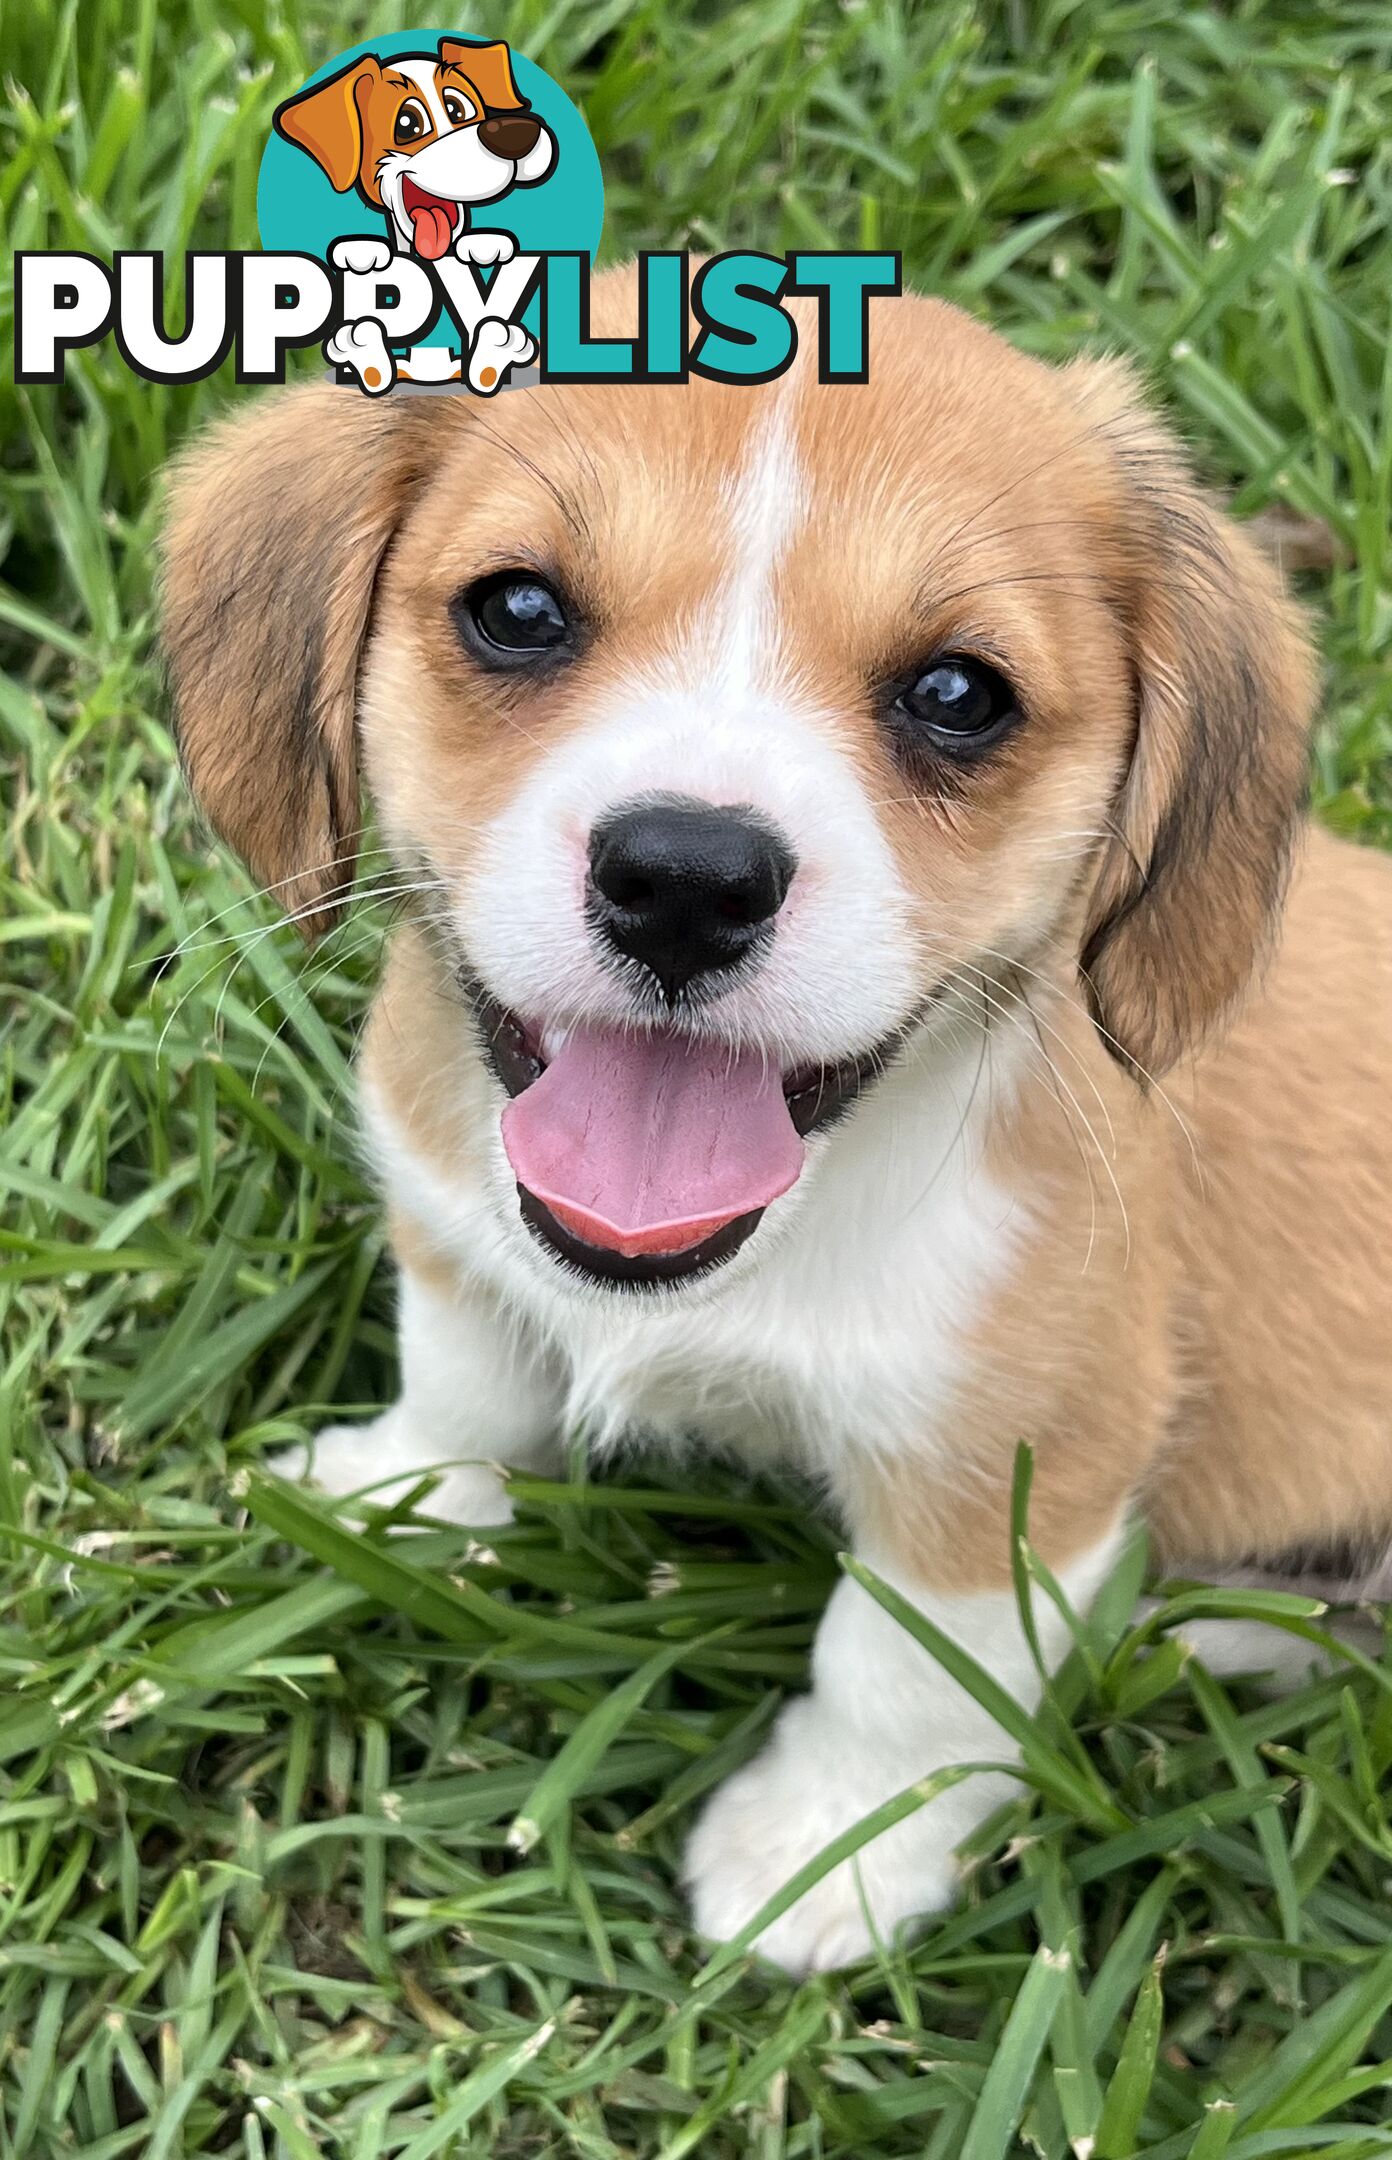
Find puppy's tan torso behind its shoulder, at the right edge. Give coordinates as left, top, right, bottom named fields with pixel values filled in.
left=1146, top=832, right=1392, bottom=1564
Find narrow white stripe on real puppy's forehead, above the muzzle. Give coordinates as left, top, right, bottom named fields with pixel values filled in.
left=709, top=382, right=808, bottom=693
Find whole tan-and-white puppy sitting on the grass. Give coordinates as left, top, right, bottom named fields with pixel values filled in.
left=166, top=272, right=1392, bottom=1972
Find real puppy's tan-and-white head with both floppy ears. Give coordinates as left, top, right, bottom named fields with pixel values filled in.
left=166, top=272, right=1312, bottom=1283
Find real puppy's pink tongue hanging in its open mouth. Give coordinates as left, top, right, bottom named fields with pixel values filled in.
left=504, top=1028, right=802, bottom=1259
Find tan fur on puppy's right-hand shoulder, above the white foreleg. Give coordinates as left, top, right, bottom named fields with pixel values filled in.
left=858, top=994, right=1182, bottom=1592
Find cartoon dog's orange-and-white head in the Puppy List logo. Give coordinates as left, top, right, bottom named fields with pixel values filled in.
left=275, top=37, right=556, bottom=261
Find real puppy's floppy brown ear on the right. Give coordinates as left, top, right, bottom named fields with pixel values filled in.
left=1072, top=361, right=1316, bottom=1097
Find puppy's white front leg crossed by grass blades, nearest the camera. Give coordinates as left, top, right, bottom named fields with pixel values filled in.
left=685, top=1512, right=1122, bottom=1974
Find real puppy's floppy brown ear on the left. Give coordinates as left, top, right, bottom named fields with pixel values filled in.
left=164, top=382, right=430, bottom=935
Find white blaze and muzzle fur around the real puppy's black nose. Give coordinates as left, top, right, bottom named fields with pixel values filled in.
left=445, top=387, right=919, bottom=1071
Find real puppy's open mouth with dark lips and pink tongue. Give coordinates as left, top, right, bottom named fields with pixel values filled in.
left=467, top=985, right=899, bottom=1287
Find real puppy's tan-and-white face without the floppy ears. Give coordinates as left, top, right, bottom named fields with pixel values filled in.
left=361, top=315, right=1130, bottom=1279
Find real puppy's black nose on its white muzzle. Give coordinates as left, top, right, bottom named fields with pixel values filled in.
left=590, top=804, right=798, bottom=1004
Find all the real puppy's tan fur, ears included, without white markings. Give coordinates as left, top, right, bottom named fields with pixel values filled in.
left=169, top=272, right=1392, bottom=1590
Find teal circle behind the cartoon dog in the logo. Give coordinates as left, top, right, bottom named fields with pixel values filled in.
left=257, top=30, right=605, bottom=346
